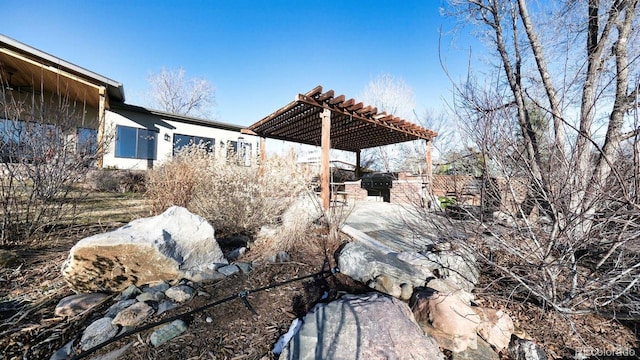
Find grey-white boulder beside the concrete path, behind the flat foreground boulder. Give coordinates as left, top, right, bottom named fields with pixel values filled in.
left=338, top=241, right=433, bottom=300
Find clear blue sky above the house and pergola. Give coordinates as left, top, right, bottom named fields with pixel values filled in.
left=0, top=0, right=477, bottom=125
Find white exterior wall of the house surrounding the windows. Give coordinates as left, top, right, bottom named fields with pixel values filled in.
left=103, top=108, right=259, bottom=170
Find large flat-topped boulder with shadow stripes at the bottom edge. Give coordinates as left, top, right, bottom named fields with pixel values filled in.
left=280, top=293, right=444, bottom=360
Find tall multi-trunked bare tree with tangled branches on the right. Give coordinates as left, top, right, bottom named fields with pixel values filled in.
left=442, top=0, right=640, bottom=312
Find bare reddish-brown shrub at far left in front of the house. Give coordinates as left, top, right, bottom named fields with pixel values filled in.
left=0, top=79, right=107, bottom=244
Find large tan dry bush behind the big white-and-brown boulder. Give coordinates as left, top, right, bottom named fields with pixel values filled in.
left=147, top=146, right=308, bottom=236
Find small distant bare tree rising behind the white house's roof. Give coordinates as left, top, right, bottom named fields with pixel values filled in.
left=148, top=68, right=216, bottom=117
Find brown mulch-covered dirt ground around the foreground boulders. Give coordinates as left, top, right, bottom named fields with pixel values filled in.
left=0, top=195, right=640, bottom=360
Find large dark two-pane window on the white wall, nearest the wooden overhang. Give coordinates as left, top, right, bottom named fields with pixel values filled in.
left=116, top=125, right=158, bottom=160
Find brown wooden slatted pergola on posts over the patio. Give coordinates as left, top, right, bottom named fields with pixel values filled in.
left=243, top=86, right=438, bottom=210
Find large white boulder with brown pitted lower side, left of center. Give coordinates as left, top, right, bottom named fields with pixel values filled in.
left=62, top=206, right=228, bottom=292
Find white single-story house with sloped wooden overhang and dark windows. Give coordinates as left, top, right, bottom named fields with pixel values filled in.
left=0, top=34, right=258, bottom=170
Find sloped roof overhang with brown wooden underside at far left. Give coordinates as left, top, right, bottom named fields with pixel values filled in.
left=0, top=34, right=125, bottom=106
